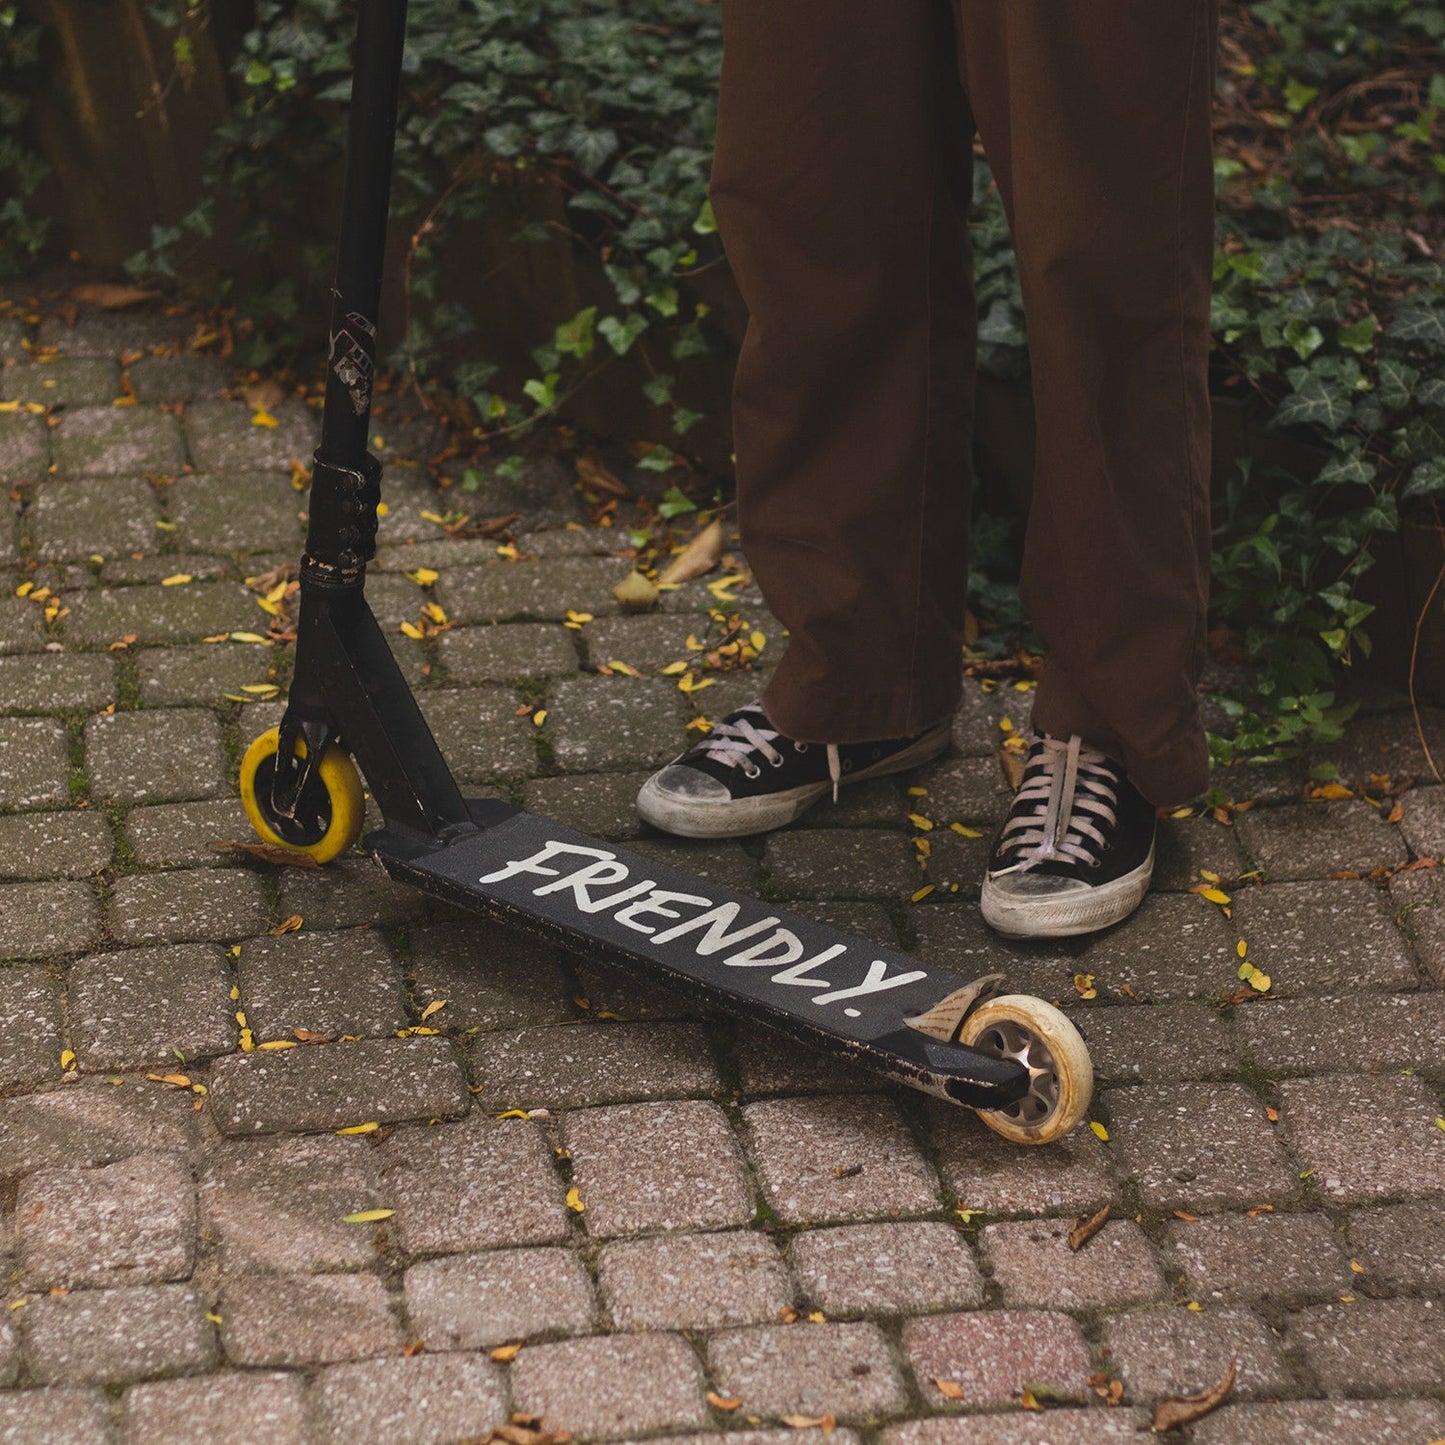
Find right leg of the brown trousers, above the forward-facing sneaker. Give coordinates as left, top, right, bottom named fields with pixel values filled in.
left=954, top=0, right=1217, bottom=805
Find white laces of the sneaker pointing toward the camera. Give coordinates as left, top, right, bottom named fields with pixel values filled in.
left=998, top=734, right=1118, bottom=873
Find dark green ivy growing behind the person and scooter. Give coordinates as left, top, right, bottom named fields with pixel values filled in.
left=0, top=0, right=1445, bottom=760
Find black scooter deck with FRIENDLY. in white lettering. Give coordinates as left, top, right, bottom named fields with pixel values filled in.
left=364, top=801, right=1029, bottom=1108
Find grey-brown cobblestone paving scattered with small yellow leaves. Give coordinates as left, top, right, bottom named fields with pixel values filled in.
left=0, top=299, right=1445, bottom=1445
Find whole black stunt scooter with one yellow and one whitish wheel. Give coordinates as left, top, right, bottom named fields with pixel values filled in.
left=241, top=0, right=1094, bottom=1144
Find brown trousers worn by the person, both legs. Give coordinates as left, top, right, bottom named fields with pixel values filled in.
left=712, top=0, right=1217, bottom=805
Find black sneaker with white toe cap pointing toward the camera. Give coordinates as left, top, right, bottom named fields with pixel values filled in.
left=981, top=736, right=1156, bottom=938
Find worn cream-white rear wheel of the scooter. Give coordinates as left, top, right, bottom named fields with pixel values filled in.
left=958, top=994, right=1094, bottom=1144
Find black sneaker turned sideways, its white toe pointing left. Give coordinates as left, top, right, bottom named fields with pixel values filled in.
left=637, top=702, right=949, bottom=838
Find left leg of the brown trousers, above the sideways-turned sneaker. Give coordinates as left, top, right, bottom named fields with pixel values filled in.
left=711, top=0, right=974, bottom=744
